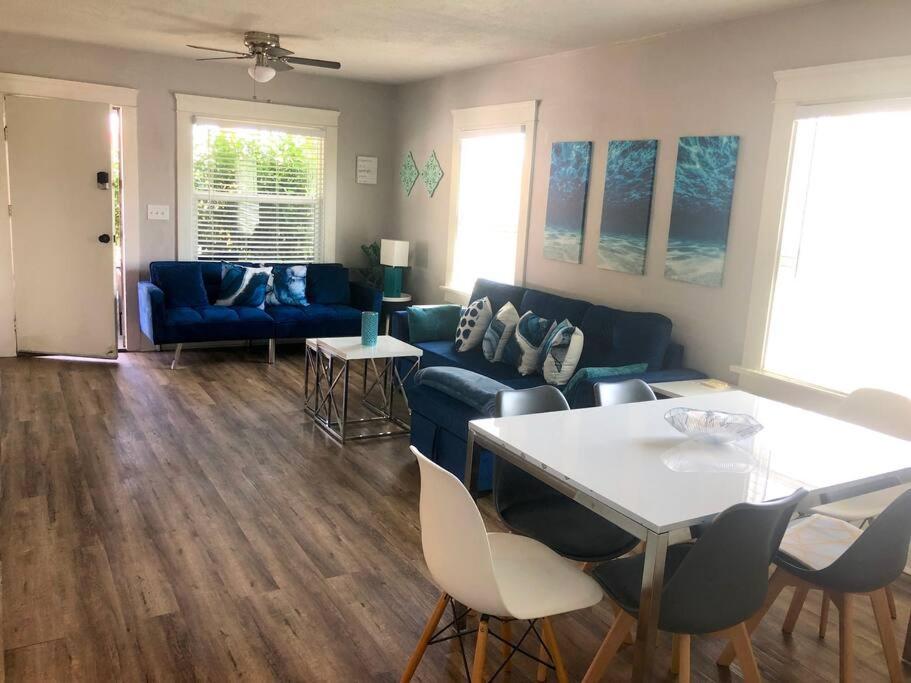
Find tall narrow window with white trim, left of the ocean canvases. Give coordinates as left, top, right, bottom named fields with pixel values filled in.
left=444, top=102, right=537, bottom=301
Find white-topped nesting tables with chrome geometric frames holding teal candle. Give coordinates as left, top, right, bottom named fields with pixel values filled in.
left=304, top=335, right=423, bottom=443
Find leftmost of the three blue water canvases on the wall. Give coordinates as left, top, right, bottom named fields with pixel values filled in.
left=544, top=142, right=592, bottom=263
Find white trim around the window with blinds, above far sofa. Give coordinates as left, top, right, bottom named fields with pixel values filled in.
left=174, top=93, right=339, bottom=263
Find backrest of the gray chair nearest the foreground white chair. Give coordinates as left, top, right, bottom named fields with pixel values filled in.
left=659, top=489, right=806, bottom=634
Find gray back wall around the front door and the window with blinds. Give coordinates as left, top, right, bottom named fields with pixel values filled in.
left=0, top=33, right=398, bottom=355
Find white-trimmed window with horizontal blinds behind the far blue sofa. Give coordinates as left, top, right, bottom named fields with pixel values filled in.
left=177, top=95, right=338, bottom=263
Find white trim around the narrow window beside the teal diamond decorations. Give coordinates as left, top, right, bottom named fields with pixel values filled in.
left=441, top=100, right=538, bottom=303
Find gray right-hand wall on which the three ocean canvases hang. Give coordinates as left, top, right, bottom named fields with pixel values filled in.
left=395, top=0, right=911, bottom=379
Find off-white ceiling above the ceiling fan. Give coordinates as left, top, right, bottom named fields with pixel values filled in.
left=0, top=0, right=818, bottom=83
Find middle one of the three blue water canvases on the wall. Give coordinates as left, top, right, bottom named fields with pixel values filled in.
left=598, top=140, right=658, bottom=275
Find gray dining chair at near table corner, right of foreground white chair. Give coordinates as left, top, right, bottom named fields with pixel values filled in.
left=583, top=489, right=806, bottom=683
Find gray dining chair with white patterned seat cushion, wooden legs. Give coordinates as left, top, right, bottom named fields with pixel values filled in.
left=718, top=491, right=911, bottom=683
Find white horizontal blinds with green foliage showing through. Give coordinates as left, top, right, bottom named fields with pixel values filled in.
left=193, top=119, right=325, bottom=263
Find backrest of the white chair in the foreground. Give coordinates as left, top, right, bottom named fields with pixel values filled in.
left=411, top=446, right=508, bottom=616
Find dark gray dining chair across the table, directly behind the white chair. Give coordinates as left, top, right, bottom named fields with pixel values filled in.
left=493, top=385, right=639, bottom=562
